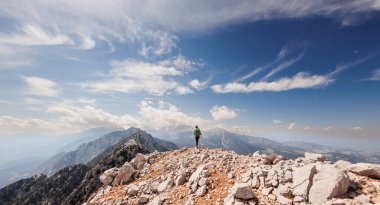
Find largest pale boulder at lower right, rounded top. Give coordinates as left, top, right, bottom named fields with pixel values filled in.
left=309, top=164, right=350, bottom=203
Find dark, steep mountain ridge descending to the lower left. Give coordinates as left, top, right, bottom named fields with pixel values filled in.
left=0, top=128, right=177, bottom=205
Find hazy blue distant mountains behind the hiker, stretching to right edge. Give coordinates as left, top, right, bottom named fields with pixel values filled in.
left=162, top=128, right=380, bottom=163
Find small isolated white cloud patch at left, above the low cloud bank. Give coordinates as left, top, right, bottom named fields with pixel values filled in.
left=23, top=76, right=59, bottom=97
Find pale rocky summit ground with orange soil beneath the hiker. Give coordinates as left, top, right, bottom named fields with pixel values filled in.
left=85, top=148, right=380, bottom=205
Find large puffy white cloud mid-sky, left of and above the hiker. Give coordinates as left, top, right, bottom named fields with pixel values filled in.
left=81, top=59, right=191, bottom=95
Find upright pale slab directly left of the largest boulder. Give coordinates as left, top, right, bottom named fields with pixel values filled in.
left=292, top=164, right=317, bottom=199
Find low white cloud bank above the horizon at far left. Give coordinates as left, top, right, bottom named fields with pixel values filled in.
left=0, top=99, right=139, bottom=135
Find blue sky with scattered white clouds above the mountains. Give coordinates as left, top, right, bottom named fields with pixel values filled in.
left=0, top=0, right=380, bottom=149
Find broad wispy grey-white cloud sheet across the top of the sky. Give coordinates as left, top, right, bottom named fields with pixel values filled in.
left=0, top=0, right=380, bottom=68
